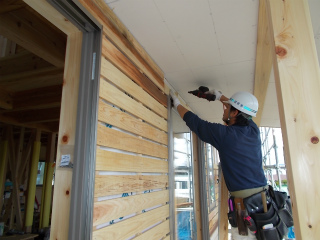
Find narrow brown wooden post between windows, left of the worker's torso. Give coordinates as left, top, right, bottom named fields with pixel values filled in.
left=192, top=132, right=202, bottom=239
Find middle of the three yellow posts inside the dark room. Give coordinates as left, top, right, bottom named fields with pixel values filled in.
left=25, top=130, right=41, bottom=232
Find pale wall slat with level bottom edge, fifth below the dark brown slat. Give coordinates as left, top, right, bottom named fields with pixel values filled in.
left=96, top=148, right=169, bottom=173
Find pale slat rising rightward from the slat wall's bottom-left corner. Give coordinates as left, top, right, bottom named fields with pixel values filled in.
left=92, top=205, right=169, bottom=240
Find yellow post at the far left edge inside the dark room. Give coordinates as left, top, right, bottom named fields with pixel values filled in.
left=0, top=127, right=8, bottom=209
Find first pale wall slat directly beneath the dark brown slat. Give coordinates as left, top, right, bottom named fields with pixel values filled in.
left=101, top=58, right=168, bottom=119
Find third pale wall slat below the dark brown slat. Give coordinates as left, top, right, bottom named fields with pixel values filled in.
left=98, top=99, right=168, bottom=145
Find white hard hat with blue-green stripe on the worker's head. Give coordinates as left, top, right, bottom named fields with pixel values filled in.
left=228, top=92, right=259, bottom=117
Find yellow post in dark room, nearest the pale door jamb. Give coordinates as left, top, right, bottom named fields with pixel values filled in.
left=40, top=133, right=57, bottom=228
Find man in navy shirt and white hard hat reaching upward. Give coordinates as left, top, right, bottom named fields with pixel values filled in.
left=170, top=90, right=267, bottom=239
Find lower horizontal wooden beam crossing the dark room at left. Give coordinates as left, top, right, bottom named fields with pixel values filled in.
left=0, top=67, right=63, bottom=92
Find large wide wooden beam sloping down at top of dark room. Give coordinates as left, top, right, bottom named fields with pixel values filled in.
left=0, top=8, right=65, bottom=67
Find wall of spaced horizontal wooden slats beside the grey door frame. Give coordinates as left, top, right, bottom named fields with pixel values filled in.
left=90, top=1, right=170, bottom=236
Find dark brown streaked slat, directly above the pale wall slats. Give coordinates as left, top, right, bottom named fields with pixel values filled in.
left=102, top=38, right=167, bottom=107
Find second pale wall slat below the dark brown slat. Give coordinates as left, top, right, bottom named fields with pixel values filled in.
left=99, top=79, right=168, bottom=132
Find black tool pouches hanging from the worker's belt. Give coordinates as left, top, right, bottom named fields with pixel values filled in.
left=243, top=186, right=293, bottom=240
